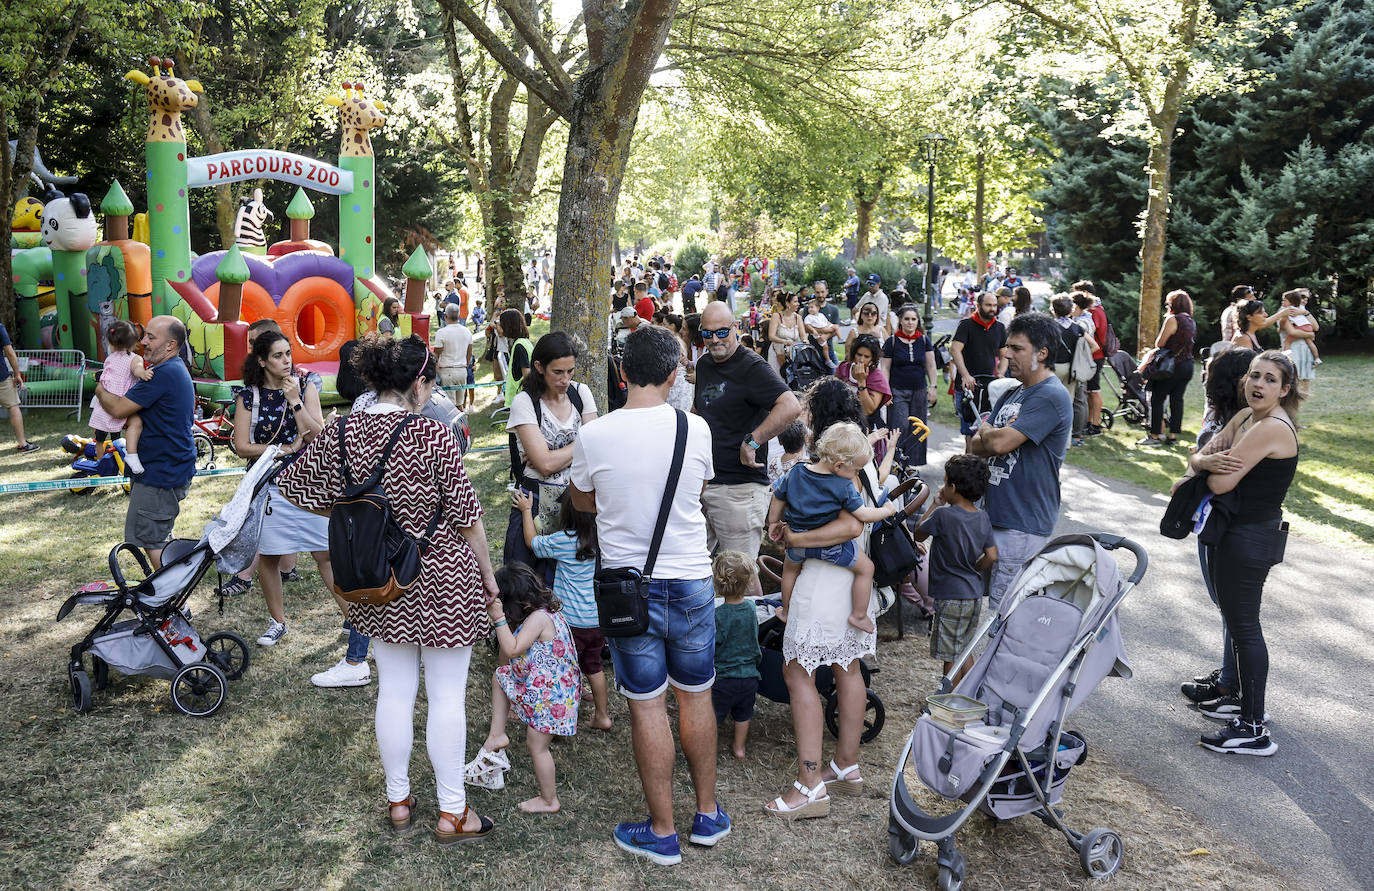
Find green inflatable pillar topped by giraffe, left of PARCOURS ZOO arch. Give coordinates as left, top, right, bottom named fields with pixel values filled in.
left=125, top=58, right=202, bottom=315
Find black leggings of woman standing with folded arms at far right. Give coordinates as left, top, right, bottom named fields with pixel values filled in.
left=1208, top=523, right=1276, bottom=723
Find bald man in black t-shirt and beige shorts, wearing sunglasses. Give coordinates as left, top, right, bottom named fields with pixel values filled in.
left=692, top=301, right=801, bottom=560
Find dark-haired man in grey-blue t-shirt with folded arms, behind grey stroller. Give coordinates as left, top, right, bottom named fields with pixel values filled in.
left=969, top=312, right=1073, bottom=609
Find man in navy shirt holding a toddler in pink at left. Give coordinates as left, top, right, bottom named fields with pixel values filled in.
left=95, top=316, right=195, bottom=568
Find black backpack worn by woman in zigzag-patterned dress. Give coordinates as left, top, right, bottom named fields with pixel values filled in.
left=330, top=414, right=444, bottom=605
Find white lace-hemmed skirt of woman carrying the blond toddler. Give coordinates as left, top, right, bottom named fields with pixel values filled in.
left=782, top=561, right=878, bottom=674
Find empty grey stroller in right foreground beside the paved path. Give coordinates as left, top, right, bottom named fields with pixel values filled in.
left=888, top=534, right=1147, bottom=891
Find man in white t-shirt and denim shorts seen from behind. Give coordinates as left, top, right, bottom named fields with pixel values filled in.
left=567, top=325, right=730, bottom=866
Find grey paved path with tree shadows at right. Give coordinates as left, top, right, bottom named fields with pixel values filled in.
left=926, top=425, right=1374, bottom=891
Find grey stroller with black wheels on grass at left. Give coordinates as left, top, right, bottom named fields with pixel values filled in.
left=56, top=447, right=286, bottom=718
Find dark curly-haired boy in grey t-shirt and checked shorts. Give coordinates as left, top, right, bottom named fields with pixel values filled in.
left=915, top=455, right=998, bottom=685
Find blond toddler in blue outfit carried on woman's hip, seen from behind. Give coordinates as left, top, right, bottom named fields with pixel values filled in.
left=768, top=422, right=897, bottom=634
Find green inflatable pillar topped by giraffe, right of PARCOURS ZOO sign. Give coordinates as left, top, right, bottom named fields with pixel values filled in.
left=326, top=81, right=386, bottom=286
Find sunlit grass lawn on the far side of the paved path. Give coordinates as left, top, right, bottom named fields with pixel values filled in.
left=936, top=347, right=1374, bottom=556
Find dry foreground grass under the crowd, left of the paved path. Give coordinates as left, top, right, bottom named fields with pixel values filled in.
left=0, top=330, right=1324, bottom=890
